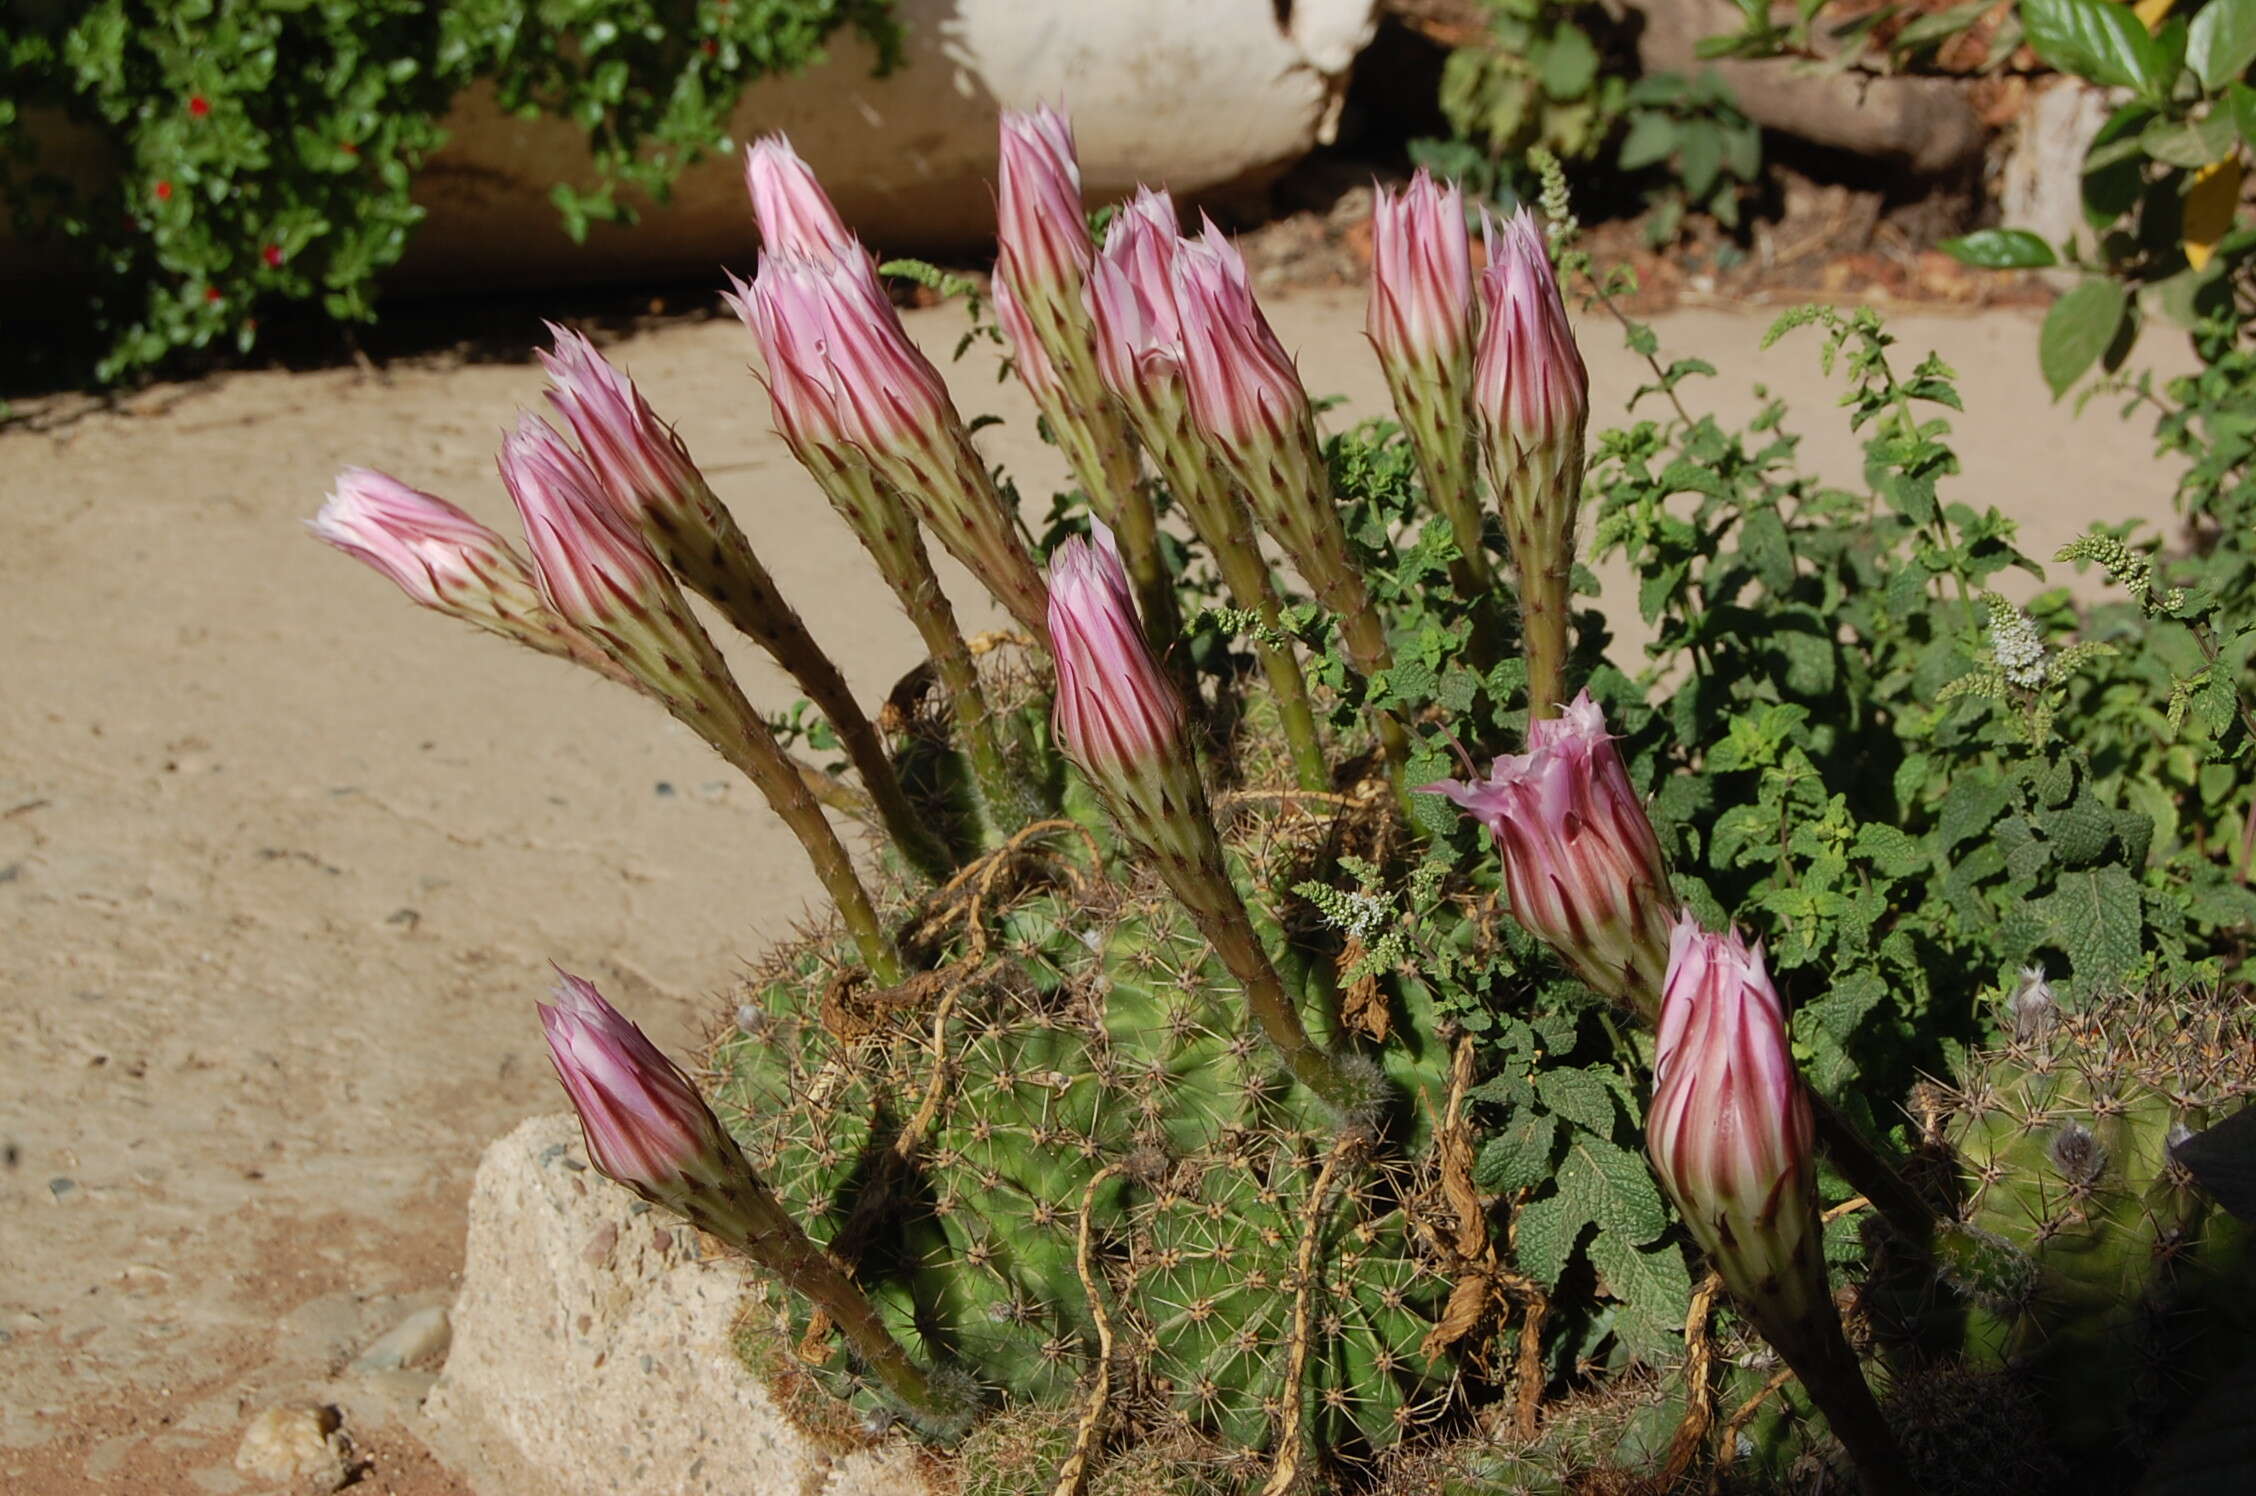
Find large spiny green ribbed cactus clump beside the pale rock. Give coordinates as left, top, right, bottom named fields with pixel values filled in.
left=713, top=866, right=1457, bottom=1458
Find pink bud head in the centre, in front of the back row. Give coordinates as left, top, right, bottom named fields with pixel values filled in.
left=1049, top=528, right=1187, bottom=787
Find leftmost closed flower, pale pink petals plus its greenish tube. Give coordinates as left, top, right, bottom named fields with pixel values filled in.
left=307, top=467, right=625, bottom=679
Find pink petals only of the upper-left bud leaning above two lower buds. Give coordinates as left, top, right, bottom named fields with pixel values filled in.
left=539, top=323, right=711, bottom=533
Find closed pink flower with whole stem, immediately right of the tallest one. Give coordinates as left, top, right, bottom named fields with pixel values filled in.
left=1087, top=187, right=1331, bottom=790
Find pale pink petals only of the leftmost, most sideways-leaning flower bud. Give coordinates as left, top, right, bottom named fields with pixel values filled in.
left=309, top=467, right=532, bottom=611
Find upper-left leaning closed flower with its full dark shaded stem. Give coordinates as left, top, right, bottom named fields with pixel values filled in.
left=541, top=323, right=952, bottom=878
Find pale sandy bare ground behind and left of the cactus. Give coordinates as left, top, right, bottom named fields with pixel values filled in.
left=0, top=293, right=2168, bottom=1496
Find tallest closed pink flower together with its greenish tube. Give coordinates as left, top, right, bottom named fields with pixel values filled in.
left=995, top=106, right=1178, bottom=643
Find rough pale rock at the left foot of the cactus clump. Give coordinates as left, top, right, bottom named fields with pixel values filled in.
left=424, top=1115, right=929, bottom=1496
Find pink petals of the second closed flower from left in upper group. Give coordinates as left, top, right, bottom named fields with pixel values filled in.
left=499, top=415, right=681, bottom=636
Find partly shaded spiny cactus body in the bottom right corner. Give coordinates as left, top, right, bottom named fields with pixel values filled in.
left=1936, top=995, right=2256, bottom=1451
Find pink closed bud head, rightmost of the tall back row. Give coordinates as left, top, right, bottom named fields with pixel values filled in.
left=1473, top=208, right=1590, bottom=455
